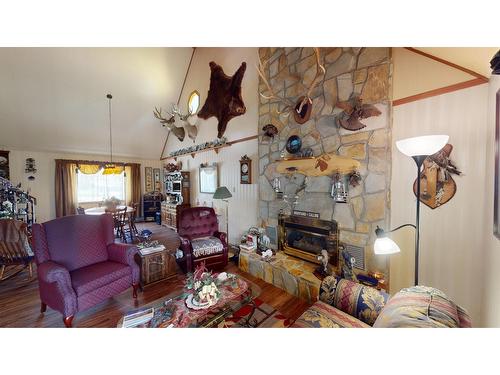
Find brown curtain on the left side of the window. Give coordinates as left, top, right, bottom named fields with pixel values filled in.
left=55, top=160, right=77, bottom=217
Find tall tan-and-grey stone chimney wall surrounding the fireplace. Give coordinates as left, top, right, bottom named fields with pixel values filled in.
left=259, top=47, right=392, bottom=275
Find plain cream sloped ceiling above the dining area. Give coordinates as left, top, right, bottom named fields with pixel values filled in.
left=0, top=48, right=192, bottom=159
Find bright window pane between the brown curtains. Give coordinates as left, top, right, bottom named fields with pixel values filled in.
left=76, top=169, right=126, bottom=203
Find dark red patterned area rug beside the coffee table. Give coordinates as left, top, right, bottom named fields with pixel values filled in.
left=219, top=298, right=293, bottom=328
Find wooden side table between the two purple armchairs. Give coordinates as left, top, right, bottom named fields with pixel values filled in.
left=136, top=249, right=177, bottom=289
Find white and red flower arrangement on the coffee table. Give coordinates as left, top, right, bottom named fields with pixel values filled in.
left=186, top=262, right=236, bottom=308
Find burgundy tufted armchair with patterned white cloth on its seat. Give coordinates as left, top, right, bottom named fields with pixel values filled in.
left=177, top=207, right=228, bottom=272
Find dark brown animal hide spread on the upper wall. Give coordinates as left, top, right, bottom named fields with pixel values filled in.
left=198, top=61, right=247, bottom=138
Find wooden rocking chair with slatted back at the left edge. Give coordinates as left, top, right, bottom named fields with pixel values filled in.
left=0, top=219, right=34, bottom=281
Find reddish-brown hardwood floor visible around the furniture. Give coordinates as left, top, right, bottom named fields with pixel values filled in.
left=0, top=226, right=309, bottom=327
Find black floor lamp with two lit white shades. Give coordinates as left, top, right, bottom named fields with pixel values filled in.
left=373, top=135, right=449, bottom=285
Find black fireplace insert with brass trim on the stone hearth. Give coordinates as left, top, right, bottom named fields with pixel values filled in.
left=278, top=214, right=339, bottom=267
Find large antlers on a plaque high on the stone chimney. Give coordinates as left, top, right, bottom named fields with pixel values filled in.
left=257, top=48, right=326, bottom=124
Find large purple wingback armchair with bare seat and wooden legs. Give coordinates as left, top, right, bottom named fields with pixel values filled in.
left=33, top=214, right=139, bottom=327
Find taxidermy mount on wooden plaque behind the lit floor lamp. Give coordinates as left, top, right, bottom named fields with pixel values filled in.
left=413, top=144, right=462, bottom=209
